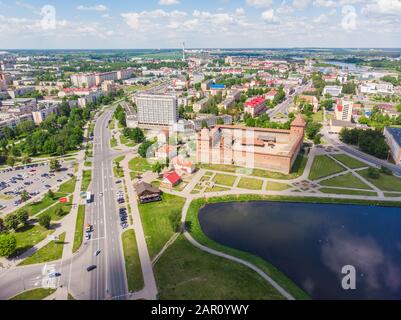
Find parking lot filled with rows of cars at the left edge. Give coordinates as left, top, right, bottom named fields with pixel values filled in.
left=0, top=161, right=74, bottom=213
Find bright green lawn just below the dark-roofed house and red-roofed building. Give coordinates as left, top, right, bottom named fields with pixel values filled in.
left=138, top=193, right=185, bottom=258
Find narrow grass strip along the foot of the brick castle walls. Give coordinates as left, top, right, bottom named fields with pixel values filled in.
left=198, top=155, right=308, bottom=180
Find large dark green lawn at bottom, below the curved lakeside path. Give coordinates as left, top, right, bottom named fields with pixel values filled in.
left=154, top=236, right=283, bottom=300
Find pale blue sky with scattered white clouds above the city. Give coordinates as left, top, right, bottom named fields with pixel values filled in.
left=0, top=0, right=401, bottom=49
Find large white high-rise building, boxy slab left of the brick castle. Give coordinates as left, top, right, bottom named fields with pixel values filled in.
left=135, top=94, right=178, bottom=126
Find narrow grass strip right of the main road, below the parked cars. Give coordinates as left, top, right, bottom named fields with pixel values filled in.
left=122, top=229, right=144, bottom=292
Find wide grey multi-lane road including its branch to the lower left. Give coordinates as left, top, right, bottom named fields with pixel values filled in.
left=0, top=109, right=128, bottom=300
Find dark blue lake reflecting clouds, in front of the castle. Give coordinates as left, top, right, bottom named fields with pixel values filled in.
left=199, top=202, right=401, bottom=299
